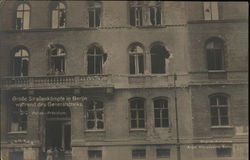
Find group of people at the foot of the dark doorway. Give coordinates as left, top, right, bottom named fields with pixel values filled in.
left=46, top=147, right=64, bottom=160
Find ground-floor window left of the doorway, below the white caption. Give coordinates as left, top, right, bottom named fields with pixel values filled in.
left=10, top=104, right=28, bottom=132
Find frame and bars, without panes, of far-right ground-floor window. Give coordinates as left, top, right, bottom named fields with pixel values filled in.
left=208, top=93, right=231, bottom=127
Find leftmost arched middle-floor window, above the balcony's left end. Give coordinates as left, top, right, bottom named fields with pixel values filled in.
left=13, top=47, right=29, bottom=76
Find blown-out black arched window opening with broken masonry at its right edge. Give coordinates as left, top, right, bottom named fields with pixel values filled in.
left=150, top=44, right=170, bottom=74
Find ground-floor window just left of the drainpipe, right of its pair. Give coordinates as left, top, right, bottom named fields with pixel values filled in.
left=154, top=99, right=169, bottom=128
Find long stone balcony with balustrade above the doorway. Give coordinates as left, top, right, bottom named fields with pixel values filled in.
left=0, top=75, right=113, bottom=89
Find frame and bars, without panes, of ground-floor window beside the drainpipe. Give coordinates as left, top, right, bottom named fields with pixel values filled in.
left=153, top=97, right=170, bottom=128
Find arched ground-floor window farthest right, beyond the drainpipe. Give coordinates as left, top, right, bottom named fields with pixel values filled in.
left=209, top=94, right=229, bottom=126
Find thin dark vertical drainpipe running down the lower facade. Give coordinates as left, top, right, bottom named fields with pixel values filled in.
left=174, top=73, right=181, bottom=160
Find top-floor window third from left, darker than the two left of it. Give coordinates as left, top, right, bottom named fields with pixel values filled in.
left=89, top=2, right=101, bottom=27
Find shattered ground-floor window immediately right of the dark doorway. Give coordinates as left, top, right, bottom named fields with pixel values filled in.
left=86, top=100, right=104, bottom=130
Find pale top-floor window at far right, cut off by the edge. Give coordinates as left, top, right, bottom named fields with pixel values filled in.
left=203, top=2, right=219, bottom=20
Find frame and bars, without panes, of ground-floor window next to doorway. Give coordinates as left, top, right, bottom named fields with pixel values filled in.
left=85, top=98, right=105, bottom=131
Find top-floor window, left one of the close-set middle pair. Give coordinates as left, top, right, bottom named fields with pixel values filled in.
left=129, top=1, right=142, bottom=26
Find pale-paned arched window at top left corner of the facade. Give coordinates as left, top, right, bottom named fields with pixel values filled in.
left=16, top=3, right=30, bottom=30
